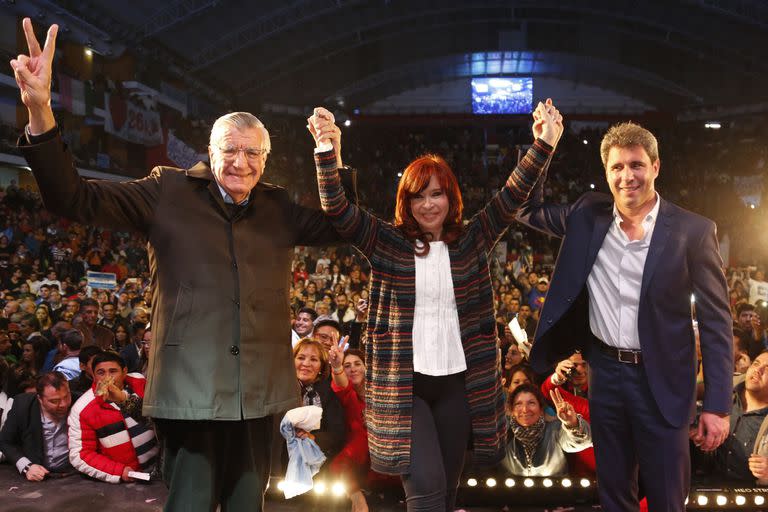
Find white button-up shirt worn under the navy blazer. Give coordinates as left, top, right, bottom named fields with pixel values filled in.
left=587, top=193, right=661, bottom=350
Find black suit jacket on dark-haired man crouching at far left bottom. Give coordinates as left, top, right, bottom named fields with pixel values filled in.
left=0, top=393, right=45, bottom=466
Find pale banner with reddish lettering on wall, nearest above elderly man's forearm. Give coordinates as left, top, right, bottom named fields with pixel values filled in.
left=104, top=93, right=163, bottom=146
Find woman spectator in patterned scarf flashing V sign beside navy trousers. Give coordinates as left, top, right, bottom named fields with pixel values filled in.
left=504, top=384, right=592, bottom=476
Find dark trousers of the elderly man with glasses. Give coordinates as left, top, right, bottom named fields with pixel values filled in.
left=155, top=416, right=272, bottom=512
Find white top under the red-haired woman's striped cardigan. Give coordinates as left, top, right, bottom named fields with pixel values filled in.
left=413, top=242, right=467, bottom=376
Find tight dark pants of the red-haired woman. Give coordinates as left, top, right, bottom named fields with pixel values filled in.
left=402, top=373, right=471, bottom=512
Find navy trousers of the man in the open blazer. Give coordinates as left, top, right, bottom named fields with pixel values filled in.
left=589, top=349, right=691, bottom=512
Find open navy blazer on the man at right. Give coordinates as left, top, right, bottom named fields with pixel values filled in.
left=518, top=177, right=733, bottom=427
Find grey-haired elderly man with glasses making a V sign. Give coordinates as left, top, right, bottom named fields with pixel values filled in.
left=11, top=19, right=354, bottom=511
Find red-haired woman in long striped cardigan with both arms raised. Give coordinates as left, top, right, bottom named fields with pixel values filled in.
left=309, top=101, right=562, bottom=511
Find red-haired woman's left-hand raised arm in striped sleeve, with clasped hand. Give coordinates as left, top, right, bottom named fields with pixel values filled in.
left=307, top=108, right=381, bottom=257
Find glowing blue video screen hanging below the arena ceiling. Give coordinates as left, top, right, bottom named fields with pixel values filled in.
left=472, top=78, right=533, bottom=114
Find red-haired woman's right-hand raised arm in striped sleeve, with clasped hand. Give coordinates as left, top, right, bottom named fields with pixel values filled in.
left=471, top=100, right=563, bottom=251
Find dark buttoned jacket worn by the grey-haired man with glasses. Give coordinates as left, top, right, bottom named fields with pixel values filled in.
left=19, top=133, right=356, bottom=420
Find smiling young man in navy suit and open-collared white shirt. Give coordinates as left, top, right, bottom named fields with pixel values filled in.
left=519, top=107, right=733, bottom=512
